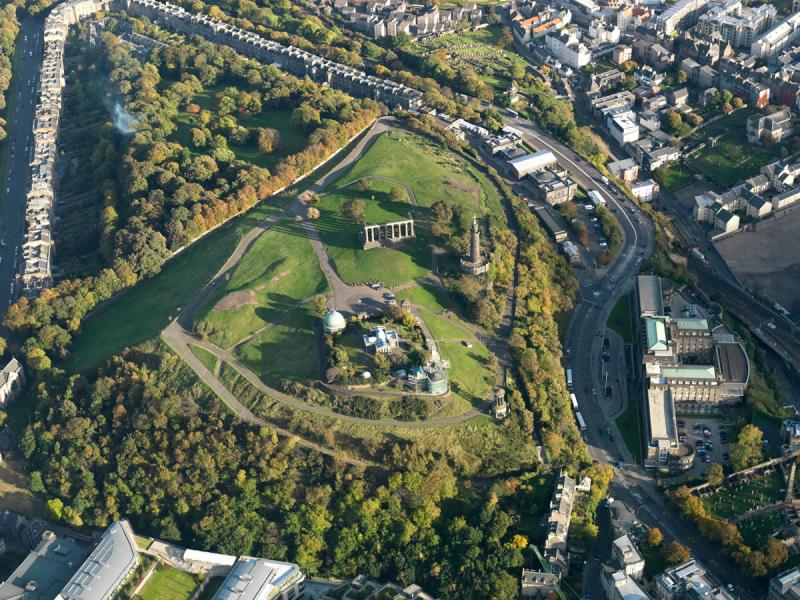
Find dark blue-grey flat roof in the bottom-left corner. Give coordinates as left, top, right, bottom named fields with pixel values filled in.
left=0, top=532, right=89, bottom=600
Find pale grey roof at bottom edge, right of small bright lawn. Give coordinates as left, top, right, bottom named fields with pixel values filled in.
left=212, top=556, right=303, bottom=600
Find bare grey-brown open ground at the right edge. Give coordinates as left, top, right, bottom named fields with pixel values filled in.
left=715, top=210, right=800, bottom=312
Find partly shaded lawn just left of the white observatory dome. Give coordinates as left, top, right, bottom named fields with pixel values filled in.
left=236, top=308, right=319, bottom=389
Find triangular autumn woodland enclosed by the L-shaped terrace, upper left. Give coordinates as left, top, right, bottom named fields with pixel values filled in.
left=5, top=34, right=381, bottom=370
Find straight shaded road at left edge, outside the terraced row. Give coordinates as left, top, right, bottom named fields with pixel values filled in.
left=0, top=17, right=44, bottom=314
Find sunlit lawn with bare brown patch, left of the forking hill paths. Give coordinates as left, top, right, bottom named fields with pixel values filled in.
left=197, top=219, right=330, bottom=348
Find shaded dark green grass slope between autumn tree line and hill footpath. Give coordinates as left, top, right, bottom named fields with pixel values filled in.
left=62, top=204, right=284, bottom=372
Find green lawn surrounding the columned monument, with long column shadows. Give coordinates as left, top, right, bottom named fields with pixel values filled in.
left=316, top=181, right=431, bottom=286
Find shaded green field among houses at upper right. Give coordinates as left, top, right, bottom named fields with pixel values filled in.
left=687, top=110, right=778, bottom=187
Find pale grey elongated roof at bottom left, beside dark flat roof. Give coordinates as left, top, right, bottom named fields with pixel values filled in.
left=57, top=520, right=139, bottom=600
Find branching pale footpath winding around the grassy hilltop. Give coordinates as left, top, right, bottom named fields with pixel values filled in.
left=161, top=118, right=494, bottom=467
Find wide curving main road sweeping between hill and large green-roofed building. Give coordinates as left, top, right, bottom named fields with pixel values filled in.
left=504, top=118, right=763, bottom=600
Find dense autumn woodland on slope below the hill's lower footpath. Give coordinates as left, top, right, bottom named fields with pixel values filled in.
left=21, top=344, right=609, bottom=599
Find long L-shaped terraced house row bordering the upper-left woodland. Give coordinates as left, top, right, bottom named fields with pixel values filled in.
left=20, top=0, right=422, bottom=296
